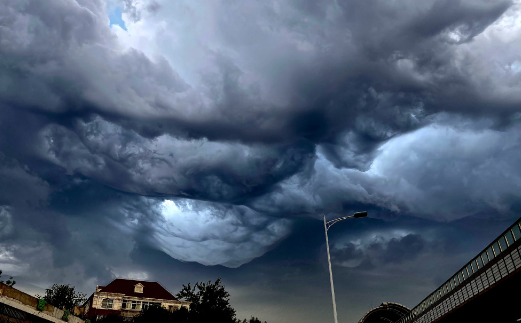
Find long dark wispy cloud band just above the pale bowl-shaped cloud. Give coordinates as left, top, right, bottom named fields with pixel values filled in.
left=40, top=118, right=314, bottom=202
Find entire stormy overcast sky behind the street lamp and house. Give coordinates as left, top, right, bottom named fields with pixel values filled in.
left=0, top=0, right=521, bottom=323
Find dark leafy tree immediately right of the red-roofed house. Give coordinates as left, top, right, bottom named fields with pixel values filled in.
left=176, top=278, right=237, bottom=323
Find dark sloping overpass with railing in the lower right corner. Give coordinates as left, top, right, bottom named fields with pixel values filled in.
left=359, top=218, right=521, bottom=323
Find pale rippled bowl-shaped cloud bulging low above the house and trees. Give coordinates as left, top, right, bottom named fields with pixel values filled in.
left=153, top=200, right=291, bottom=268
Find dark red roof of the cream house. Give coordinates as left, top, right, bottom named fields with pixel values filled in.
left=100, top=278, right=177, bottom=301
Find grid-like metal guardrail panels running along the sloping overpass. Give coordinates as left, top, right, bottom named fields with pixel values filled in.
left=396, top=218, right=521, bottom=323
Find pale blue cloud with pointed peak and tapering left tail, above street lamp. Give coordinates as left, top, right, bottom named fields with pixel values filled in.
left=252, top=121, right=521, bottom=221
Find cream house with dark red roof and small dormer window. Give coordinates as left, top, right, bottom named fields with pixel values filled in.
left=84, top=278, right=190, bottom=319
